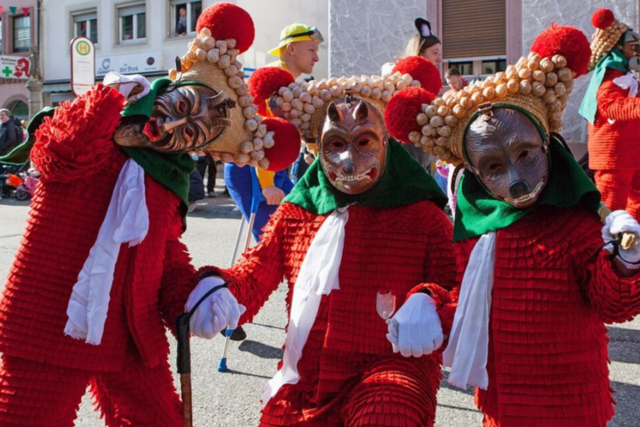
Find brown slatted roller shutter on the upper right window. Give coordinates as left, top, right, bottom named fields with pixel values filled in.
left=441, top=0, right=507, bottom=60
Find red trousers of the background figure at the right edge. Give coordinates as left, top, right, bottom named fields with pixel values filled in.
left=595, top=169, right=640, bottom=221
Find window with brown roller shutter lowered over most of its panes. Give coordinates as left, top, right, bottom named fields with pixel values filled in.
left=442, top=0, right=507, bottom=79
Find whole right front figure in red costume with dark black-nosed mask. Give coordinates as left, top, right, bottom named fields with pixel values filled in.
left=396, top=26, right=640, bottom=427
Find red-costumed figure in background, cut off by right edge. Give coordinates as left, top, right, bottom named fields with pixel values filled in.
left=580, top=9, right=640, bottom=219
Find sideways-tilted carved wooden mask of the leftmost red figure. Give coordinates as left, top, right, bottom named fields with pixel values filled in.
left=114, top=85, right=235, bottom=152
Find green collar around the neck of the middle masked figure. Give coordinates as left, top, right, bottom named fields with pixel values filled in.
left=284, top=138, right=447, bottom=215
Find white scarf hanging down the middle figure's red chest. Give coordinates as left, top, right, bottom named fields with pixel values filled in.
left=262, top=207, right=349, bottom=405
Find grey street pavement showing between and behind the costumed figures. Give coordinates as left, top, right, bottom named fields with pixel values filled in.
left=0, top=186, right=640, bottom=427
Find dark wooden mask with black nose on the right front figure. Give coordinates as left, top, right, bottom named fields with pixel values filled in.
left=465, top=108, right=549, bottom=208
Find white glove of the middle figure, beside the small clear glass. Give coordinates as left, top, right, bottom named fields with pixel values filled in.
left=387, top=293, right=443, bottom=357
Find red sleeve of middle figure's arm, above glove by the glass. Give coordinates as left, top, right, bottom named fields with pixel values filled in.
left=407, top=205, right=459, bottom=335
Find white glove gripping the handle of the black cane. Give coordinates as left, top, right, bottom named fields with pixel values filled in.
left=184, top=276, right=246, bottom=339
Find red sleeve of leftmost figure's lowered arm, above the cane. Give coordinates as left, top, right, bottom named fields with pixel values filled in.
left=160, top=219, right=198, bottom=334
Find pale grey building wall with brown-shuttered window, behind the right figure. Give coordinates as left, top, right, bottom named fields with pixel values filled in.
left=329, top=0, right=640, bottom=147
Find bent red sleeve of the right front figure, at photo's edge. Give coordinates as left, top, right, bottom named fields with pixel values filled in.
left=573, top=209, right=640, bottom=323
